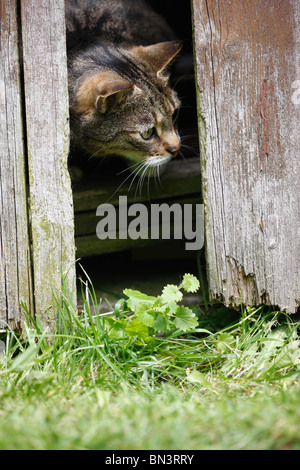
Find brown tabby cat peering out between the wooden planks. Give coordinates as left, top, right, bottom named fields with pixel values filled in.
left=65, top=0, right=182, bottom=177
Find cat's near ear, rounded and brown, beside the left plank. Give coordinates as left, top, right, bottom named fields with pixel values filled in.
left=76, top=71, right=134, bottom=114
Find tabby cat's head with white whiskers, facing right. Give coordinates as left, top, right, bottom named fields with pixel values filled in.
left=71, top=41, right=181, bottom=176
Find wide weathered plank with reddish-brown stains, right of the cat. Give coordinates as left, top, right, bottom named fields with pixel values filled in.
left=193, top=0, right=300, bottom=313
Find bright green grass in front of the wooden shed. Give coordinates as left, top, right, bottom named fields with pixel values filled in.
left=0, top=278, right=300, bottom=450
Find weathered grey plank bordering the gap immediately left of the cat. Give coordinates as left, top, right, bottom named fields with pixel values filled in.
left=21, top=0, right=75, bottom=325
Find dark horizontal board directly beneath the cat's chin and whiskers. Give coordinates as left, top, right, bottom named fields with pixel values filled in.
left=73, top=157, right=201, bottom=212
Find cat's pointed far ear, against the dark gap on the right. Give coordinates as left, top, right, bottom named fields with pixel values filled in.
left=132, top=41, right=182, bottom=74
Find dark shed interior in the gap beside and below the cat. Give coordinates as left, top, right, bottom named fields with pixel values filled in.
left=73, top=0, right=201, bottom=302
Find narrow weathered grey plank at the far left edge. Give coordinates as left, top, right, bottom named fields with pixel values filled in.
left=0, top=0, right=32, bottom=328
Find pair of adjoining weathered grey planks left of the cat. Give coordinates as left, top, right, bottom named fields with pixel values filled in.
left=0, top=0, right=75, bottom=325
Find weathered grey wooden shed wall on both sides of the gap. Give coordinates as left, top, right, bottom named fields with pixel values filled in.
left=0, top=0, right=300, bottom=327
